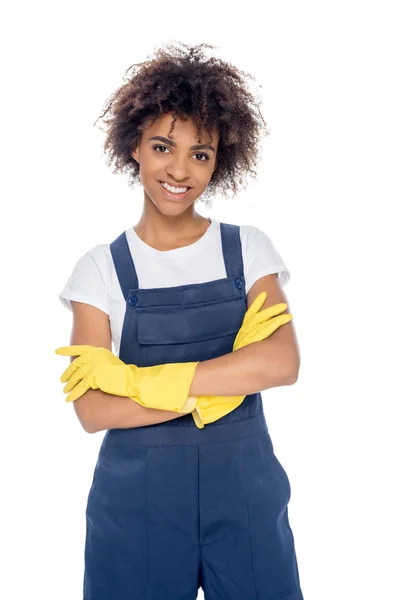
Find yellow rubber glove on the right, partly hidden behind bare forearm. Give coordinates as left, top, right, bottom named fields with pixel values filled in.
left=189, top=292, right=293, bottom=429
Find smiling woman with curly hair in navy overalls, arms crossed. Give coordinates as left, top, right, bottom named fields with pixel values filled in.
left=60, top=44, right=303, bottom=600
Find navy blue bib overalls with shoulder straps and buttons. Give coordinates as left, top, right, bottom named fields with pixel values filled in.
left=84, top=223, right=303, bottom=600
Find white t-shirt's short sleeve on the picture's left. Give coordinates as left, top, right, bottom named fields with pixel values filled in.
left=58, top=246, right=110, bottom=315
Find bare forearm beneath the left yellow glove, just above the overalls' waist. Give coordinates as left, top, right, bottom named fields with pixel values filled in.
left=74, top=389, right=189, bottom=433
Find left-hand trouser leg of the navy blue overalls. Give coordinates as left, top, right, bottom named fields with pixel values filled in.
left=84, top=445, right=199, bottom=600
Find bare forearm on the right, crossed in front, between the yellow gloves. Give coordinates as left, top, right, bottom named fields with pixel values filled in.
left=189, top=340, right=295, bottom=396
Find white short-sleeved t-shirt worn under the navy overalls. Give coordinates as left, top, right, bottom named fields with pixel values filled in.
left=59, top=217, right=290, bottom=355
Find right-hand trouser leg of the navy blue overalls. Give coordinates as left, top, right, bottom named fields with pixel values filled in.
left=199, top=432, right=303, bottom=600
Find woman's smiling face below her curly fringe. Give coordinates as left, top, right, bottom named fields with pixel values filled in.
left=132, top=113, right=219, bottom=215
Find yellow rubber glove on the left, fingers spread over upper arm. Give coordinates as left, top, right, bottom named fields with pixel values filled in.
left=55, top=345, right=199, bottom=413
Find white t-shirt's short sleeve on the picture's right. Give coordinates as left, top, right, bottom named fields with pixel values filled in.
left=243, top=225, right=291, bottom=293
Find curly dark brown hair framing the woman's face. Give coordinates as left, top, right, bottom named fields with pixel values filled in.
left=95, top=42, right=269, bottom=202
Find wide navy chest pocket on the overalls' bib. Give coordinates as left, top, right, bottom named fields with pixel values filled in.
left=136, top=297, right=246, bottom=352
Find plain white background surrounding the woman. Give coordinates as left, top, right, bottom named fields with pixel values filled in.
left=0, top=0, right=400, bottom=600
